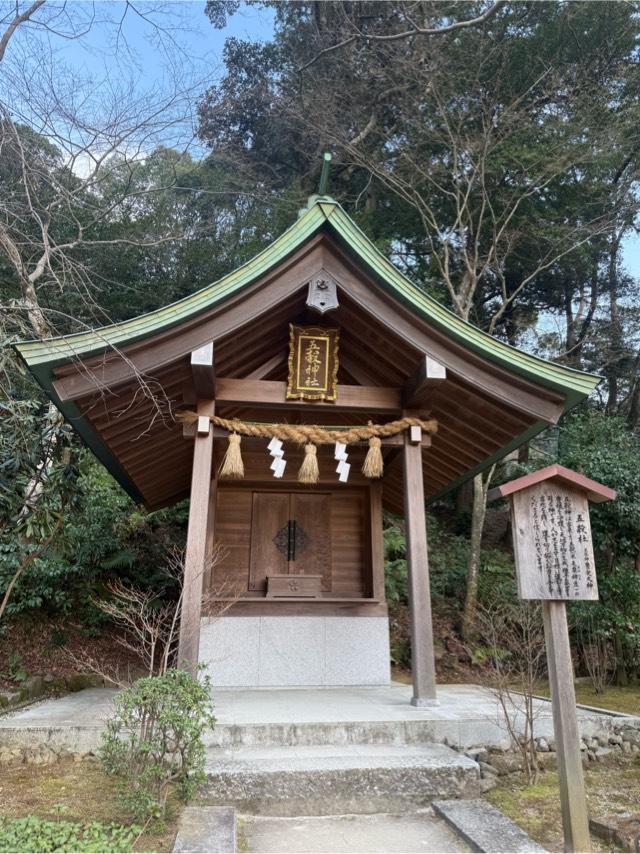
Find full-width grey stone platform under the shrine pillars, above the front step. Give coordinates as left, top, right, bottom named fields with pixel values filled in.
left=0, top=683, right=637, bottom=758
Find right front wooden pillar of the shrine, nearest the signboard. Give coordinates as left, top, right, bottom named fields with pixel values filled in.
left=403, top=427, right=437, bottom=706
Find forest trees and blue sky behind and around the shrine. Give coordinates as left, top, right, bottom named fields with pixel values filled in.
left=0, top=0, right=640, bottom=688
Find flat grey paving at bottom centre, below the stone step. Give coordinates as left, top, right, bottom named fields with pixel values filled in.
left=242, top=809, right=468, bottom=854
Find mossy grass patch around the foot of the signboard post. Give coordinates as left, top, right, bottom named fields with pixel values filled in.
left=486, top=755, right=640, bottom=851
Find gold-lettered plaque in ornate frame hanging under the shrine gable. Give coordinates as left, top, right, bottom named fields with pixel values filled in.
left=287, top=323, right=340, bottom=401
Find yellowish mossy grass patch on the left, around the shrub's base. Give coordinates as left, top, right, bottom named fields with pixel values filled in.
left=0, top=762, right=180, bottom=852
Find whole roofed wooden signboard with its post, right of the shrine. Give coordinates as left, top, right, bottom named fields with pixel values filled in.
left=488, top=465, right=616, bottom=851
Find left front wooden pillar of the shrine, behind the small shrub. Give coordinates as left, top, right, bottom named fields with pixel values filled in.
left=178, top=400, right=215, bottom=674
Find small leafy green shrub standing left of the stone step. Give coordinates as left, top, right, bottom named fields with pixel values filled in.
left=100, top=670, right=215, bottom=820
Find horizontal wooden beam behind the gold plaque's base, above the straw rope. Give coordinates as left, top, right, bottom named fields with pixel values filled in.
left=216, top=377, right=401, bottom=413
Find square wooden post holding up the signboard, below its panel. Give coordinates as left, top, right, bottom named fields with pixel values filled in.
left=542, top=600, right=591, bottom=852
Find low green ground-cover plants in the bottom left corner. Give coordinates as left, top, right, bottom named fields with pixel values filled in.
left=0, top=815, right=142, bottom=852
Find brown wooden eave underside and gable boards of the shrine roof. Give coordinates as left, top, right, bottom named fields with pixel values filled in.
left=48, top=234, right=566, bottom=512
